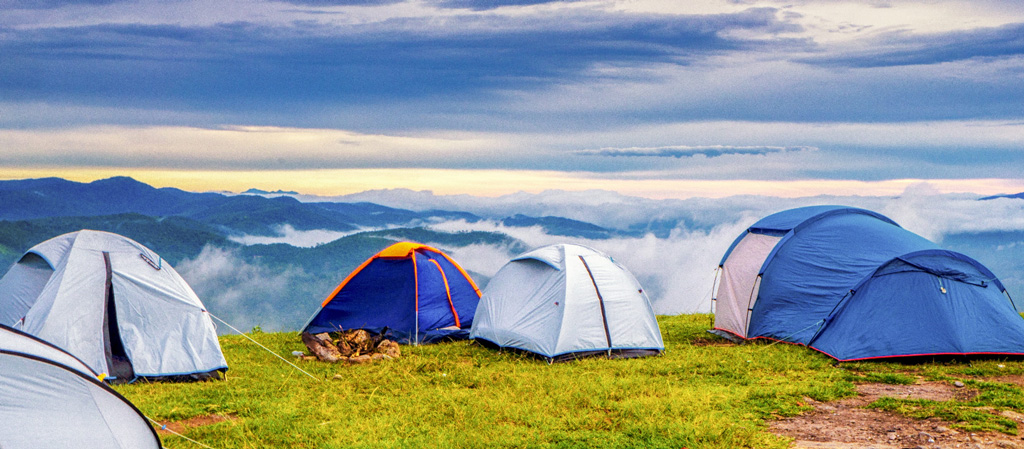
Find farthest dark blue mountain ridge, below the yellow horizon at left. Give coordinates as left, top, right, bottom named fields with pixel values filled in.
left=0, top=176, right=614, bottom=239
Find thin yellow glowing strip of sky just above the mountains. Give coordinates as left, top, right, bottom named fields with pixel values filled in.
left=0, top=167, right=1024, bottom=199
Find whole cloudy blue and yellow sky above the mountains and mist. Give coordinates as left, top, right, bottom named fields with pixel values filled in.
left=0, top=0, right=1024, bottom=199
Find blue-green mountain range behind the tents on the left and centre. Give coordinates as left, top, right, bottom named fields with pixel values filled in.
left=0, top=177, right=617, bottom=329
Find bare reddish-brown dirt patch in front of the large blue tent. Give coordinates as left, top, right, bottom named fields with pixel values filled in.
left=769, top=382, right=1024, bottom=449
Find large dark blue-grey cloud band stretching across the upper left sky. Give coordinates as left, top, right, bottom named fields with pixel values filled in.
left=0, top=8, right=792, bottom=116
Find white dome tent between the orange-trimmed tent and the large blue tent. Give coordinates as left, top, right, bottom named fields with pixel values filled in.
left=471, top=245, right=665, bottom=361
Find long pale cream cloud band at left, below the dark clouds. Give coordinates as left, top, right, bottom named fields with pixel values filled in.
left=0, top=126, right=488, bottom=170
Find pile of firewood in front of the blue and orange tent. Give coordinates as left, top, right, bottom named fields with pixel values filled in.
left=302, top=329, right=401, bottom=364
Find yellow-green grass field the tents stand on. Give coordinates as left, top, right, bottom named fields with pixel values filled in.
left=117, top=315, right=1024, bottom=449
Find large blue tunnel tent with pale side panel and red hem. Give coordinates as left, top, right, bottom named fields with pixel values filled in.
left=713, top=206, right=1024, bottom=360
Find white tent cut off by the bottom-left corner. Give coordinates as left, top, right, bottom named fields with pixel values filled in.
left=0, top=326, right=161, bottom=449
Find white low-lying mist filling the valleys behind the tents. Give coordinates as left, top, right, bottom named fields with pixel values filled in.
left=178, top=185, right=1024, bottom=330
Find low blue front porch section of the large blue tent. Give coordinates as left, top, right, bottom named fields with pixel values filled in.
left=809, top=250, right=1024, bottom=361
